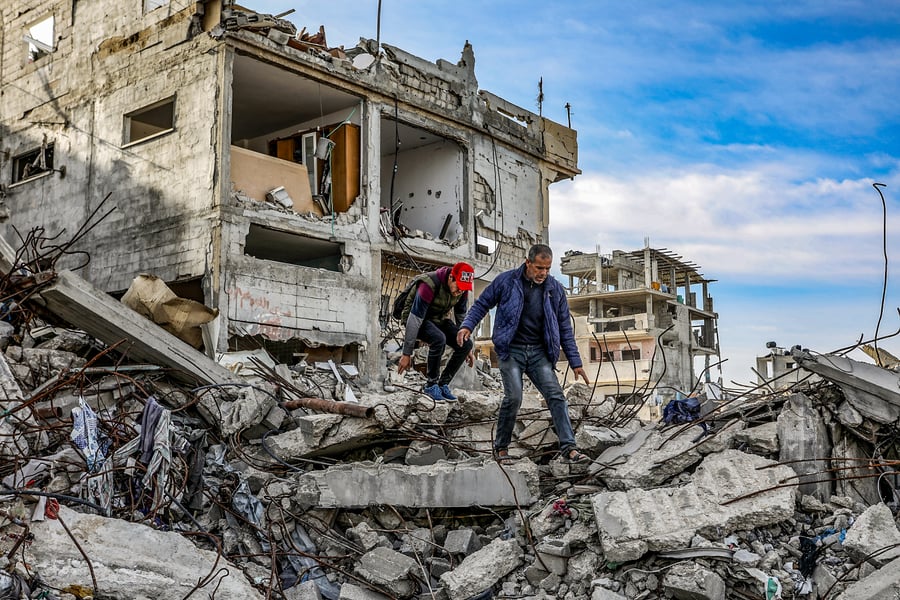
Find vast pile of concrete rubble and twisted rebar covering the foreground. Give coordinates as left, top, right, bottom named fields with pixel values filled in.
left=0, top=274, right=900, bottom=600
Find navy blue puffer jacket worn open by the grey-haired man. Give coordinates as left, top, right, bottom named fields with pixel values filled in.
left=460, top=264, right=582, bottom=369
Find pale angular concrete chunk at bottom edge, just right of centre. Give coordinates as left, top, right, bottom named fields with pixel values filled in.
left=441, top=539, right=522, bottom=600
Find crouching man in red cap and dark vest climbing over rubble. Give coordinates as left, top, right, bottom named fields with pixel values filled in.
left=397, top=262, right=475, bottom=402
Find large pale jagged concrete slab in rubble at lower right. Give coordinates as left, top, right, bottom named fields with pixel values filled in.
left=591, top=450, right=796, bottom=562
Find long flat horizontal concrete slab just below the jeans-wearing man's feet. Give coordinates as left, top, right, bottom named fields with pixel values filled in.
left=298, top=459, right=539, bottom=508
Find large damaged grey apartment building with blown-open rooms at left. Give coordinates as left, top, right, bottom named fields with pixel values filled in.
left=0, top=0, right=579, bottom=378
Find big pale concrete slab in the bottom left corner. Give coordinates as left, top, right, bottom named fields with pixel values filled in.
left=26, top=506, right=263, bottom=600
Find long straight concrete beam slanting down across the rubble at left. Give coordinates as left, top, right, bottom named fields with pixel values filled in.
left=40, top=271, right=245, bottom=385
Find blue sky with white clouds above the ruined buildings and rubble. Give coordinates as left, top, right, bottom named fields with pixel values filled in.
left=256, top=0, right=900, bottom=385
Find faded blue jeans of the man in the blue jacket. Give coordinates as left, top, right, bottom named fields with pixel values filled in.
left=494, top=345, right=575, bottom=452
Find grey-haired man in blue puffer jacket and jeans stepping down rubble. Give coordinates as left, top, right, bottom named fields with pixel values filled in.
left=456, top=244, right=590, bottom=463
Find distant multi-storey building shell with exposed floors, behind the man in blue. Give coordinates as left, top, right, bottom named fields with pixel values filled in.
left=561, top=241, right=719, bottom=418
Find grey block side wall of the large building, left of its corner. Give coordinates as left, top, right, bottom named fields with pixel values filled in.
left=0, top=3, right=218, bottom=290
